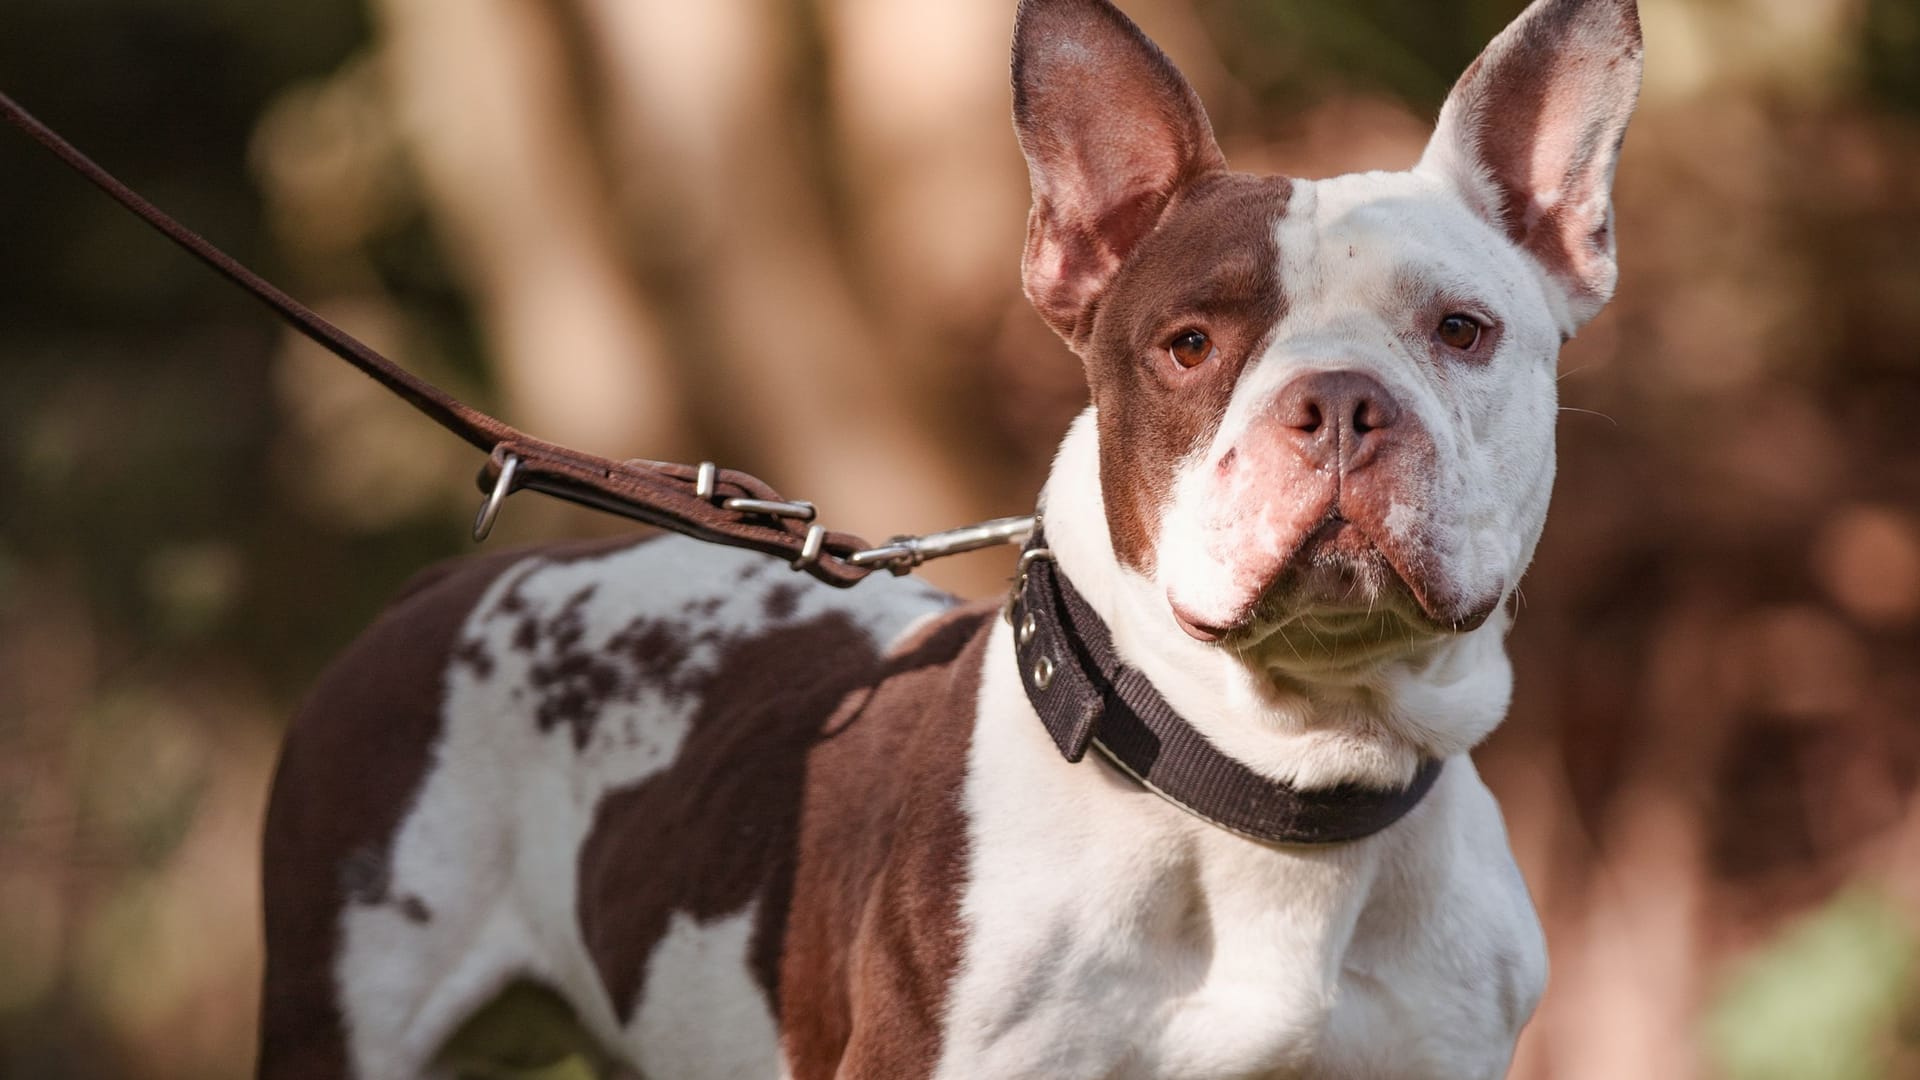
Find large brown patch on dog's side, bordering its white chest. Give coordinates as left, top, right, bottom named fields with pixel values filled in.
left=578, top=609, right=991, bottom=1080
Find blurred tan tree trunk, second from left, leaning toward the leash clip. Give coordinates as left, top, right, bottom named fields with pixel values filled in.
left=580, top=0, right=979, bottom=532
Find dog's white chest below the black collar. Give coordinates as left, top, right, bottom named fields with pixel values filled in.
left=939, top=614, right=1540, bottom=1080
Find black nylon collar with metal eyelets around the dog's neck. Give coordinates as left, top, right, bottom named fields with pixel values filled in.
left=1008, top=532, right=1440, bottom=844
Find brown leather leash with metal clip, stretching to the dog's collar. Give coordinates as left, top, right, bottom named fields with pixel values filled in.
left=0, top=92, right=1033, bottom=588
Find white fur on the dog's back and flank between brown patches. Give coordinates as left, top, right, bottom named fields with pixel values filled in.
left=334, top=538, right=948, bottom=1080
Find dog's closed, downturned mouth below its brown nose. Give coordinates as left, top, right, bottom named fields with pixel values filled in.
left=1169, top=511, right=1498, bottom=663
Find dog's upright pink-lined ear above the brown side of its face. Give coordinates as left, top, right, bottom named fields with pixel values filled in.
left=1014, top=0, right=1225, bottom=342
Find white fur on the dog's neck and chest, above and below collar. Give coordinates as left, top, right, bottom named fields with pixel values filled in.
left=937, top=413, right=1546, bottom=1080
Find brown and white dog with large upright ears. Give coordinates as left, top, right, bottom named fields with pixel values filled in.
left=261, top=0, right=1642, bottom=1080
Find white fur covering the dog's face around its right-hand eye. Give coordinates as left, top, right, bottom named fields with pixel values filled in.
left=1158, top=173, right=1559, bottom=653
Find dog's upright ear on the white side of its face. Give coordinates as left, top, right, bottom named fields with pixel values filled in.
left=1419, top=0, right=1642, bottom=334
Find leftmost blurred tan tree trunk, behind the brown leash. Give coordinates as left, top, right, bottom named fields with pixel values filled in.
left=376, top=0, right=693, bottom=457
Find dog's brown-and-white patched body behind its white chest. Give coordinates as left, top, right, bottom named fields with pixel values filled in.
left=261, top=538, right=991, bottom=1076
